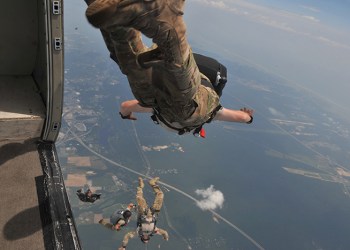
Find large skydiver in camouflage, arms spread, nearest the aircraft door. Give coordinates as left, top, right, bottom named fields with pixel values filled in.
left=85, top=0, right=253, bottom=137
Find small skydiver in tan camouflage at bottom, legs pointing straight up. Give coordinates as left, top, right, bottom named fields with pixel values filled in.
left=119, top=177, right=169, bottom=250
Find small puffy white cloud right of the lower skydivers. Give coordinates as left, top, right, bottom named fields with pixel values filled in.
left=195, top=185, right=225, bottom=210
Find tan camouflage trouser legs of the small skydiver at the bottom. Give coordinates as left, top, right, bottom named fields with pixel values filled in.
left=136, top=182, right=164, bottom=216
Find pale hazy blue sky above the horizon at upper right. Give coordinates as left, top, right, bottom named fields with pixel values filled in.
left=185, top=0, right=350, bottom=116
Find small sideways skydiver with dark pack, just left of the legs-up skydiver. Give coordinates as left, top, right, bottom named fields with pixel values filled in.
left=99, top=203, right=136, bottom=231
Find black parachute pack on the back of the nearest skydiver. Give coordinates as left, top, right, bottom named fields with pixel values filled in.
left=193, top=53, right=227, bottom=97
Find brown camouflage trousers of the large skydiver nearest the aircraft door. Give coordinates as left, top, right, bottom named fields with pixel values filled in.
left=93, top=2, right=219, bottom=127
